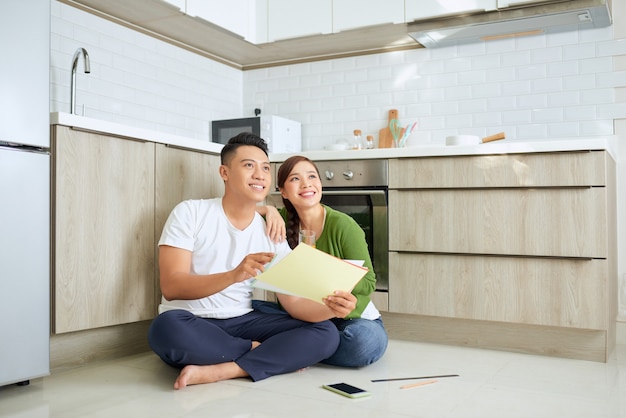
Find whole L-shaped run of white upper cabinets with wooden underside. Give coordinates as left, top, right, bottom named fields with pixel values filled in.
left=59, top=0, right=611, bottom=70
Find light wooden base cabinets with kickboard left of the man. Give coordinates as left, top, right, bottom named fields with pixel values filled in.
left=51, top=125, right=223, bottom=369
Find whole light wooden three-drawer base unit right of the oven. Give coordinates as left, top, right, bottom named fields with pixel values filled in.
left=385, top=150, right=617, bottom=361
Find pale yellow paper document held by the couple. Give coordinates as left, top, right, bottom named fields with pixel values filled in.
left=252, top=244, right=368, bottom=303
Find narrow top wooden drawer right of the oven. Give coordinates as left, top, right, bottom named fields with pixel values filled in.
left=389, top=151, right=607, bottom=189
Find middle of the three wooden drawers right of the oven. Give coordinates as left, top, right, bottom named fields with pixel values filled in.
left=389, top=187, right=607, bottom=258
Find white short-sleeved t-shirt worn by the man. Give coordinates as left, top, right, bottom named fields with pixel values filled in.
left=159, top=198, right=291, bottom=319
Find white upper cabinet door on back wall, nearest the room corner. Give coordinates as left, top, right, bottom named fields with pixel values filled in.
left=267, top=0, right=333, bottom=42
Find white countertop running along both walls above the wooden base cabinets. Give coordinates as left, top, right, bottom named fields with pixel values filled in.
left=50, top=112, right=617, bottom=162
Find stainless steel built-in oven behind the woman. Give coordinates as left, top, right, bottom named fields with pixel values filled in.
left=270, top=160, right=389, bottom=291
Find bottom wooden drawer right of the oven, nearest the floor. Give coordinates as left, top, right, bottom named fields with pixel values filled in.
left=389, top=253, right=614, bottom=329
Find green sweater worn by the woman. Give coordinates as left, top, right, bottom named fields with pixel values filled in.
left=279, top=205, right=376, bottom=319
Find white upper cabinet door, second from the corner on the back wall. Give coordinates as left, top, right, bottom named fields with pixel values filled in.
left=332, top=0, right=404, bottom=33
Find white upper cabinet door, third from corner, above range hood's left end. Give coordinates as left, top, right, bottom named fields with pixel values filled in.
left=405, top=0, right=497, bottom=22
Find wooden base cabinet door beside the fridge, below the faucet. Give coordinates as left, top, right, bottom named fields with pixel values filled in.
left=52, top=126, right=156, bottom=334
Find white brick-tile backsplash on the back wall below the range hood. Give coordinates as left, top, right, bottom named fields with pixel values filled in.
left=243, top=28, right=626, bottom=150
